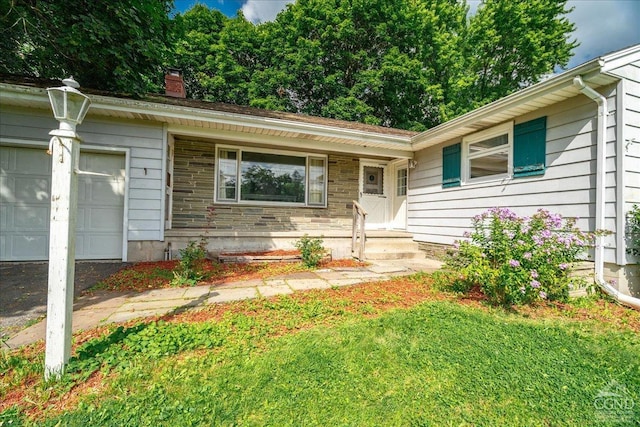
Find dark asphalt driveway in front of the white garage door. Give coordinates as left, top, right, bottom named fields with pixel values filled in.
left=0, top=261, right=127, bottom=340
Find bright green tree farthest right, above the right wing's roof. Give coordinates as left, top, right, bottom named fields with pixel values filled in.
left=452, top=0, right=578, bottom=112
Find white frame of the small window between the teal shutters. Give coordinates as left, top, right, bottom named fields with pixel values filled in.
left=460, top=122, right=513, bottom=185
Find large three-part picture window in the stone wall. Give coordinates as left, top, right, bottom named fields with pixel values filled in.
left=216, top=147, right=327, bottom=206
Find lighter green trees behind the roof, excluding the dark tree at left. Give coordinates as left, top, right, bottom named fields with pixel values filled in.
left=174, top=0, right=576, bottom=130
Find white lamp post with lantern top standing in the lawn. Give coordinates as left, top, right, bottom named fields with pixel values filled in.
left=44, top=77, right=91, bottom=379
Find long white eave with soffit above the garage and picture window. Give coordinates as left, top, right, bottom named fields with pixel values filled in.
left=0, top=83, right=417, bottom=158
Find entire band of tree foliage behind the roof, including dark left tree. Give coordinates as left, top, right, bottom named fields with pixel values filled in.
left=0, top=0, right=577, bottom=130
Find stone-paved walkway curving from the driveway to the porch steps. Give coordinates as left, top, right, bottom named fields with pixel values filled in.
left=3, top=259, right=441, bottom=349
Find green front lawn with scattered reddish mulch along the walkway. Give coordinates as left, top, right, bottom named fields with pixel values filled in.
left=0, top=275, right=640, bottom=426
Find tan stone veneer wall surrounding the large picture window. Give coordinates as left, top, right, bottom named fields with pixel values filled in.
left=172, top=140, right=359, bottom=231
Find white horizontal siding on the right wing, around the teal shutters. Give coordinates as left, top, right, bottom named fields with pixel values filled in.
left=407, top=86, right=616, bottom=262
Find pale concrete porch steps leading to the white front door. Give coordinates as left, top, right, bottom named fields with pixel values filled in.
left=364, top=230, right=425, bottom=260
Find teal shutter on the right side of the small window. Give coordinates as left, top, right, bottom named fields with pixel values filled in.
left=513, top=117, right=547, bottom=177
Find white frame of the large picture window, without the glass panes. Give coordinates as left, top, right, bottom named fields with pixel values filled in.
left=213, top=144, right=329, bottom=208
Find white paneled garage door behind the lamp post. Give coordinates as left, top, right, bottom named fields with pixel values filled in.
left=0, top=147, right=125, bottom=261
